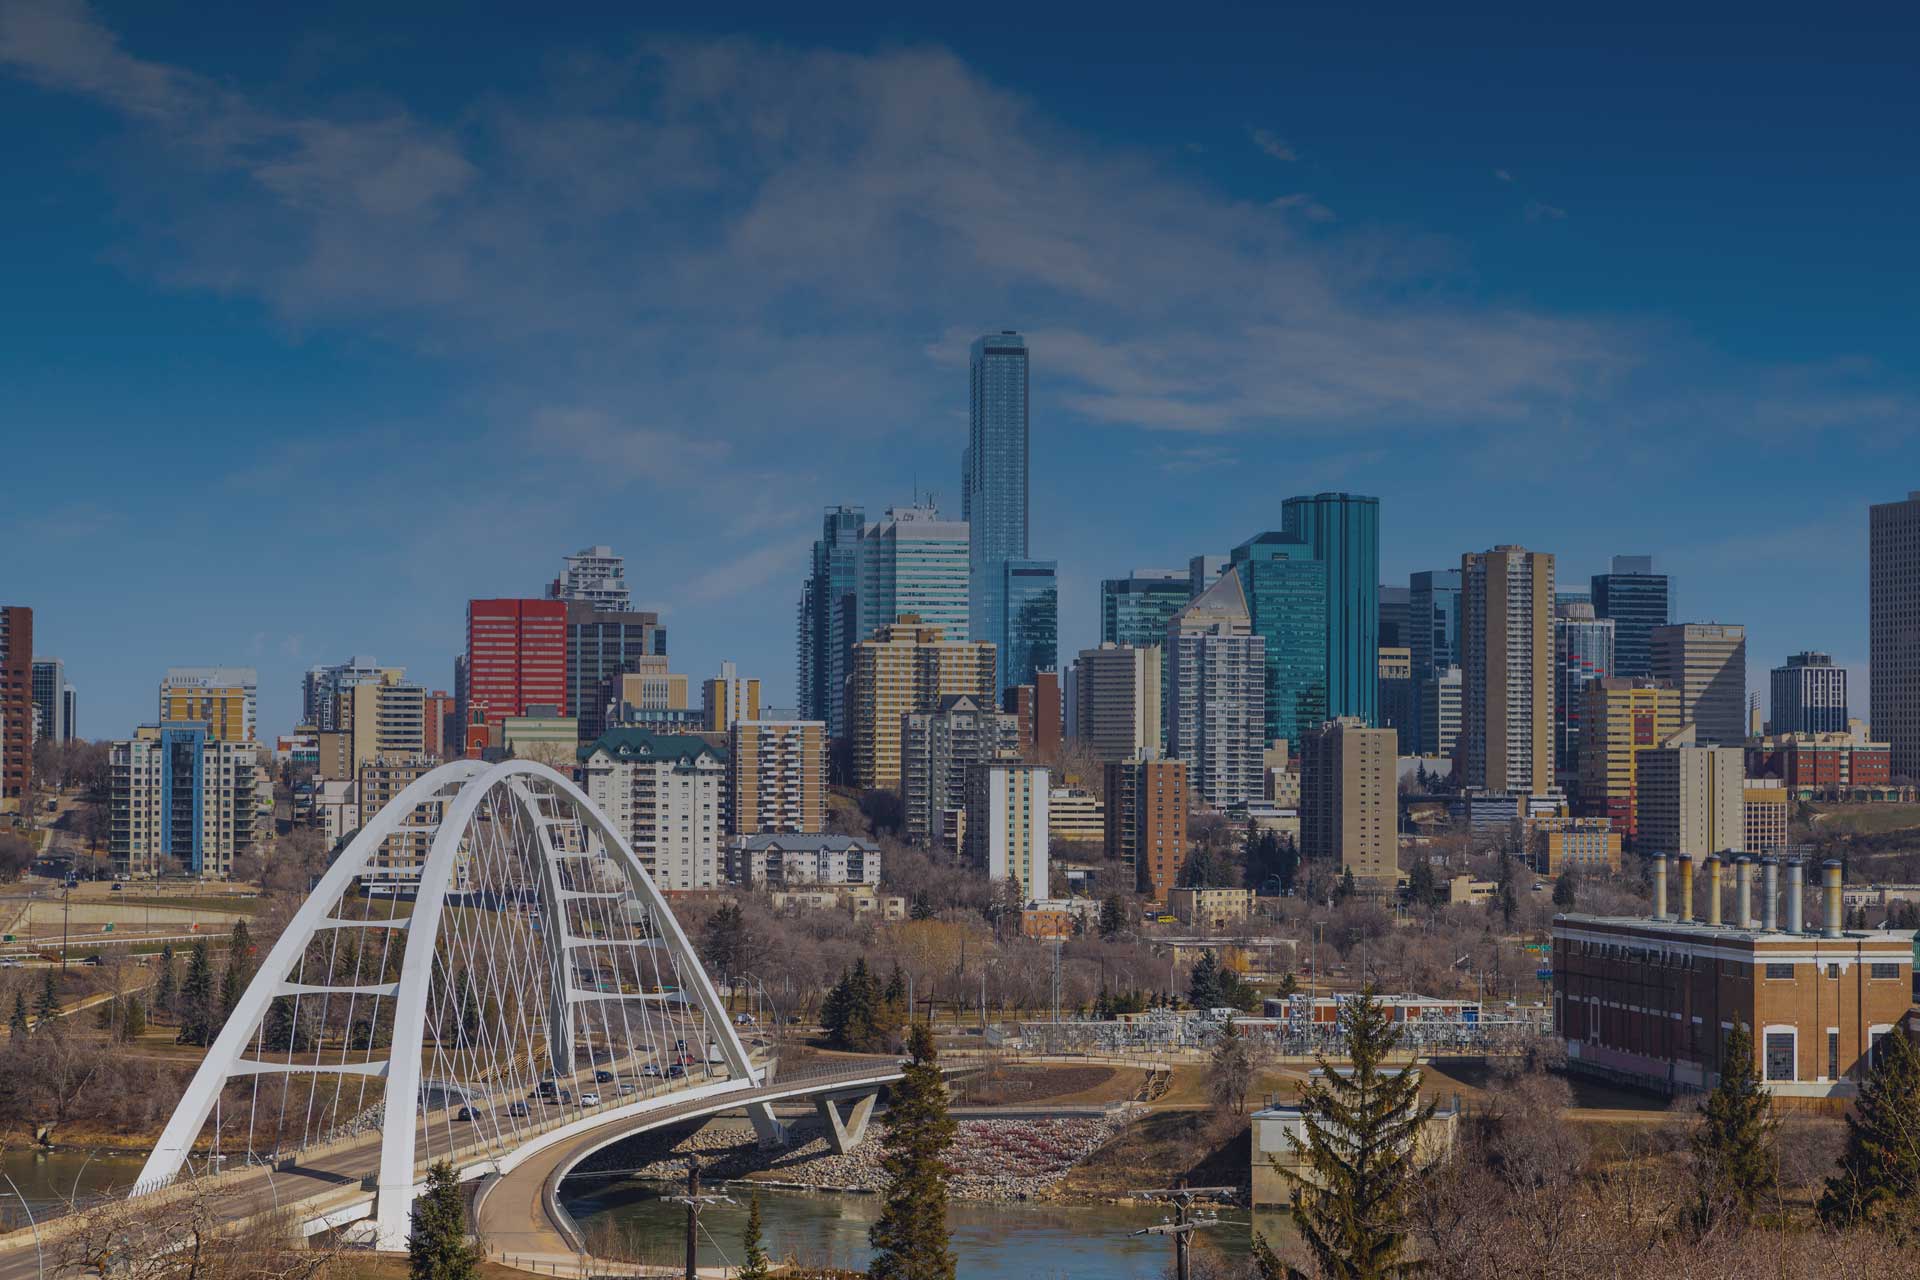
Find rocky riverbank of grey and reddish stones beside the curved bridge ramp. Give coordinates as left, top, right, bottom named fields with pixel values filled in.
left=582, top=1115, right=1125, bottom=1201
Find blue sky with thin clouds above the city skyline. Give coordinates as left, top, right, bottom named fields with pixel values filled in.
left=0, top=0, right=1920, bottom=735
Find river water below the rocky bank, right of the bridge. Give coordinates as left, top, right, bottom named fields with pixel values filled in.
left=563, top=1178, right=1286, bottom=1280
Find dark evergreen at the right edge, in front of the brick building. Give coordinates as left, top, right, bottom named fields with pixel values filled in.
left=1820, top=1031, right=1920, bottom=1226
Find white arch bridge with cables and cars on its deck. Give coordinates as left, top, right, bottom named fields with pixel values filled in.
left=134, top=760, right=899, bottom=1249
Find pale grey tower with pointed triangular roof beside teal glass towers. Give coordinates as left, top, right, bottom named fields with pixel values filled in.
left=1167, top=566, right=1267, bottom=810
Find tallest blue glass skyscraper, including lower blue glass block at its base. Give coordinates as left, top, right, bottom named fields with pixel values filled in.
left=967, top=330, right=1060, bottom=693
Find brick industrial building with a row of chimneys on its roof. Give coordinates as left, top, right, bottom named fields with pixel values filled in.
left=1553, top=854, right=1912, bottom=1098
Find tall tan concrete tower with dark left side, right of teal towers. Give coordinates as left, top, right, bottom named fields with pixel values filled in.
left=1459, top=545, right=1553, bottom=793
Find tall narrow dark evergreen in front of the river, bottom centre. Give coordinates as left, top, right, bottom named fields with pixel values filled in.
left=868, top=1023, right=954, bottom=1280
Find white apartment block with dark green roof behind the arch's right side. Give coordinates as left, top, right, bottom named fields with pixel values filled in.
left=578, top=729, right=728, bottom=890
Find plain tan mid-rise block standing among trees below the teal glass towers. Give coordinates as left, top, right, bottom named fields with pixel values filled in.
left=1300, top=716, right=1400, bottom=892
